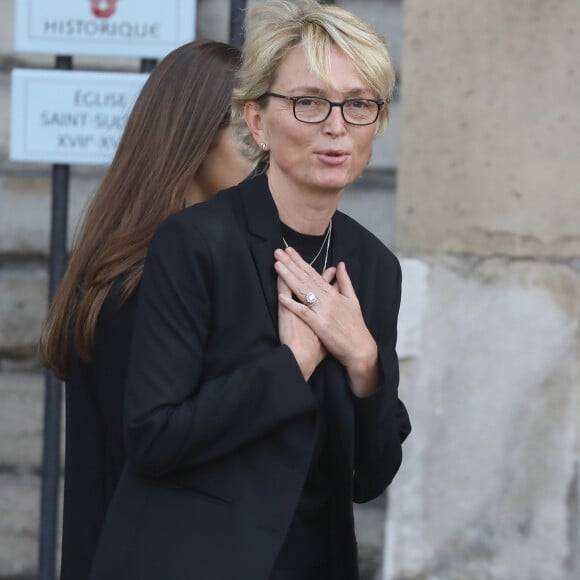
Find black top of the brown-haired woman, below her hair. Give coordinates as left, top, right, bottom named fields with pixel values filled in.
left=60, top=282, right=137, bottom=580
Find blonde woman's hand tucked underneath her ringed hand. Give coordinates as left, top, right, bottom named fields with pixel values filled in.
left=278, top=268, right=335, bottom=381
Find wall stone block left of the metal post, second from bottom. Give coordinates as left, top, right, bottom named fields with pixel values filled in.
left=0, top=372, right=44, bottom=468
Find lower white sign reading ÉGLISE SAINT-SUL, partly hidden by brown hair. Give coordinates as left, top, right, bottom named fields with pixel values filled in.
left=10, top=69, right=149, bottom=165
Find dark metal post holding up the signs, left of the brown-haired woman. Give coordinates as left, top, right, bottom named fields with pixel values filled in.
left=38, top=56, right=72, bottom=580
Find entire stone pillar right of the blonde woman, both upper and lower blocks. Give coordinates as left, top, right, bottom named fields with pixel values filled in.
left=383, top=0, right=580, bottom=580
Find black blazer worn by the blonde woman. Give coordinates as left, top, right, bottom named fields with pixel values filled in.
left=91, top=175, right=410, bottom=580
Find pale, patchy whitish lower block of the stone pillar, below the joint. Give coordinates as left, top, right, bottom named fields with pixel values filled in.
left=385, top=259, right=580, bottom=580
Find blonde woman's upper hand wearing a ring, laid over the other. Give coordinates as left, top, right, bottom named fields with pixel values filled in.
left=274, top=248, right=378, bottom=397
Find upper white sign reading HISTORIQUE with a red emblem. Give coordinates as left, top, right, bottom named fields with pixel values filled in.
left=14, top=0, right=197, bottom=58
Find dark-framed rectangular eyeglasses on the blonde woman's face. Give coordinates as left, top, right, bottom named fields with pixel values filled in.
left=262, top=93, right=385, bottom=125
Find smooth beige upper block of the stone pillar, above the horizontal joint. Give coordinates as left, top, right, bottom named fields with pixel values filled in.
left=397, top=0, right=580, bottom=258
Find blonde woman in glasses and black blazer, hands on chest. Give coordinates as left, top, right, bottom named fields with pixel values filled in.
left=92, top=1, right=410, bottom=580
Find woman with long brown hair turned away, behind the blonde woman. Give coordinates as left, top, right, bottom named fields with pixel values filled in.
left=40, top=41, right=251, bottom=580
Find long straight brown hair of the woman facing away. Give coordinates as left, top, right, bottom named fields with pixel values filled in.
left=40, top=41, right=240, bottom=379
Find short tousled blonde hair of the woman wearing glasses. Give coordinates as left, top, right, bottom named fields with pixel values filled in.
left=232, top=0, right=395, bottom=162
